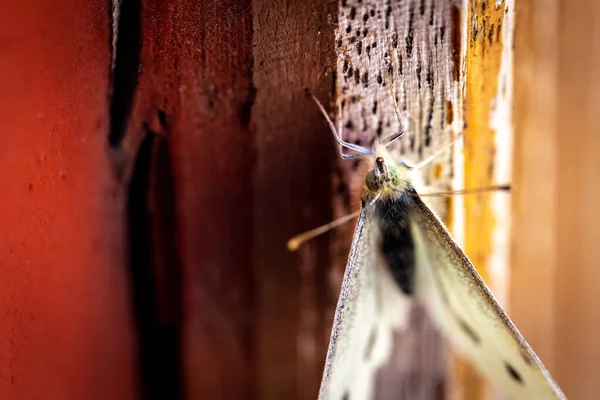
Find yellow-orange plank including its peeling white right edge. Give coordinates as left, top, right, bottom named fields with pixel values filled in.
left=454, top=0, right=514, bottom=399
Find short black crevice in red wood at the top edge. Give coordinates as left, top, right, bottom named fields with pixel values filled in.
left=108, top=0, right=141, bottom=148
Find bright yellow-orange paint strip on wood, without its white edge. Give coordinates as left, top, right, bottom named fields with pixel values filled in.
left=460, top=0, right=511, bottom=399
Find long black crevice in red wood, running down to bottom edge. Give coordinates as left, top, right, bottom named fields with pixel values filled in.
left=127, top=129, right=183, bottom=399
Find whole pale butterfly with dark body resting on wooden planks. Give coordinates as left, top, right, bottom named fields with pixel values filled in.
left=292, top=91, right=566, bottom=400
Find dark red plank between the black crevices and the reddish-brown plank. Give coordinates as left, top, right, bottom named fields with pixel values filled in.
left=125, top=0, right=256, bottom=399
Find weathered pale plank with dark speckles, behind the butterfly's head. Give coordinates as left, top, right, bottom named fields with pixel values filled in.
left=330, top=0, right=463, bottom=399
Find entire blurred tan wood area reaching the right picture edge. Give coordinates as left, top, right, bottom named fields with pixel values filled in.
left=511, top=1, right=600, bottom=399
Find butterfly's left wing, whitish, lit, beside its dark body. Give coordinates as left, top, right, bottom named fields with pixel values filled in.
left=319, top=209, right=411, bottom=400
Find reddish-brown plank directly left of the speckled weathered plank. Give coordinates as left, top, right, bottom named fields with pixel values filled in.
left=252, top=0, right=337, bottom=399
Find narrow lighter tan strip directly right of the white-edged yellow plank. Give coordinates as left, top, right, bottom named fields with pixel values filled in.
left=510, top=1, right=556, bottom=382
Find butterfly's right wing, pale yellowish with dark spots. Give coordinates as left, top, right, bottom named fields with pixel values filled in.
left=410, top=197, right=566, bottom=399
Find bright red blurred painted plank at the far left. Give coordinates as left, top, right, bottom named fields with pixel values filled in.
left=0, top=0, right=136, bottom=399
